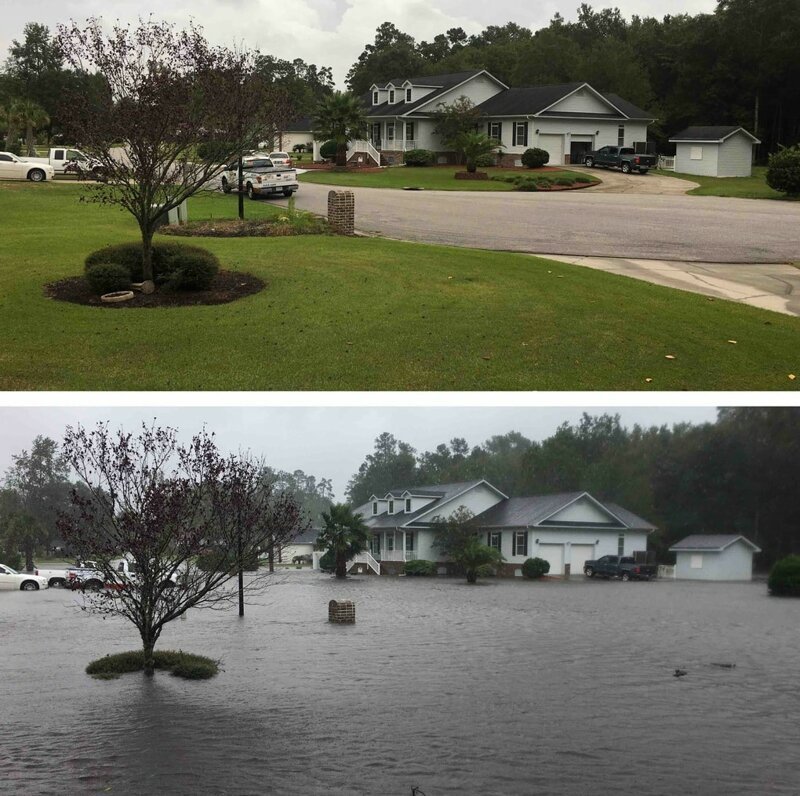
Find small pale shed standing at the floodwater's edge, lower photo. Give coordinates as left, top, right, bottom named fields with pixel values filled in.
left=670, top=534, right=761, bottom=580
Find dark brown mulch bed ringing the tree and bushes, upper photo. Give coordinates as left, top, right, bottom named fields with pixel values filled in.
left=44, top=271, right=266, bottom=310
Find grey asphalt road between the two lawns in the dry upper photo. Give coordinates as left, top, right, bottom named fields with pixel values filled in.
left=296, top=175, right=800, bottom=264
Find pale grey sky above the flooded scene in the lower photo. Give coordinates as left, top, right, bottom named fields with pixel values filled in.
left=0, top=406, right=716, bottom=500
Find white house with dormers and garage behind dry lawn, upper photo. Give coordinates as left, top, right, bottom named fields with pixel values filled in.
left=351, top=70, right=653, bottom=166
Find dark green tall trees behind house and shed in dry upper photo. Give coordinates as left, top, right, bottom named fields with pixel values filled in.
left=347, top=0, right=800, bottom=158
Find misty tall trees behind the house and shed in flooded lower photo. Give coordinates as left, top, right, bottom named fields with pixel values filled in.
left=347, top=407, right=800, bottom=567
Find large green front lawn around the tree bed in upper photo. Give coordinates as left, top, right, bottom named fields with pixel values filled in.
left=0, top=182, right=800, bottom=390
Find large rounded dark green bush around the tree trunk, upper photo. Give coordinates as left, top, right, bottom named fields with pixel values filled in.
left=84, top=243, right=219, bottom=292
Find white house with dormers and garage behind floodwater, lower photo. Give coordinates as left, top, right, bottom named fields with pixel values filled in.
left=354, top=480, right=655, bottom=575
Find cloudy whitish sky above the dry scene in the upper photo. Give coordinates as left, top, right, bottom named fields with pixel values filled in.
left=0, top=0, right=717, bottom=88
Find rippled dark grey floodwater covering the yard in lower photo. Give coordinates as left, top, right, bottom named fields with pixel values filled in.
left=0, top=570, right=800, bottom=796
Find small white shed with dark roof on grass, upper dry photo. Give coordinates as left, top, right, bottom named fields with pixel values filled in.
left=669, top=127, right=761, bottom=177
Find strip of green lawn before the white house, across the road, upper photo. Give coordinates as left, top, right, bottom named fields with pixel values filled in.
left=298, top=166, right=599, bottom=191
